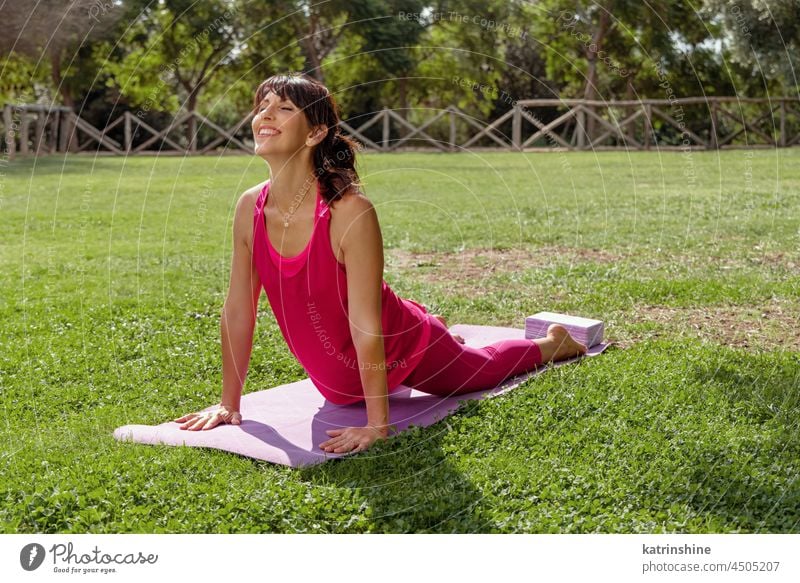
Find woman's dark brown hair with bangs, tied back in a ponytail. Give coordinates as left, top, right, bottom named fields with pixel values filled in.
left=253, top=73, right=362, bottom=204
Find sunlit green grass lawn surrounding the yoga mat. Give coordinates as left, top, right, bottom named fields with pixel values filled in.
left=0, top=150, right=800, bottom=533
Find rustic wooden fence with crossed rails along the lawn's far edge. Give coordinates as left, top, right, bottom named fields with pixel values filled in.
left=3, top=97, right=800, bottom=158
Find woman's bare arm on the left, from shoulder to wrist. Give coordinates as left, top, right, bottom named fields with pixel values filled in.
left=220, top=187, right=261, bottom=411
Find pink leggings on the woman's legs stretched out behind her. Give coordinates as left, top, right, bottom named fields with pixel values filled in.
left=403, top=317, right=542, bottom=396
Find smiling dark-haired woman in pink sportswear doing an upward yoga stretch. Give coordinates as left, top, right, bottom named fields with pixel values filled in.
left=175, top=74, right=586, bottom=453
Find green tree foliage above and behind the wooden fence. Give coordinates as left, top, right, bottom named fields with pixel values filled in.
left=0, top=0, right=800, bottom=129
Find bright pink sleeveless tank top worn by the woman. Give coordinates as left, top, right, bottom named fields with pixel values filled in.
left=253, top=181, right=431, bottom=405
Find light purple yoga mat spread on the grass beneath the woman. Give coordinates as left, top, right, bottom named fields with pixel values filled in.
left=114, top=324, right=611, bottom=467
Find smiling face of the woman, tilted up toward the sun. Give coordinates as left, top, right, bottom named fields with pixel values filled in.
left=251, top=91, right=310, bottom=158
